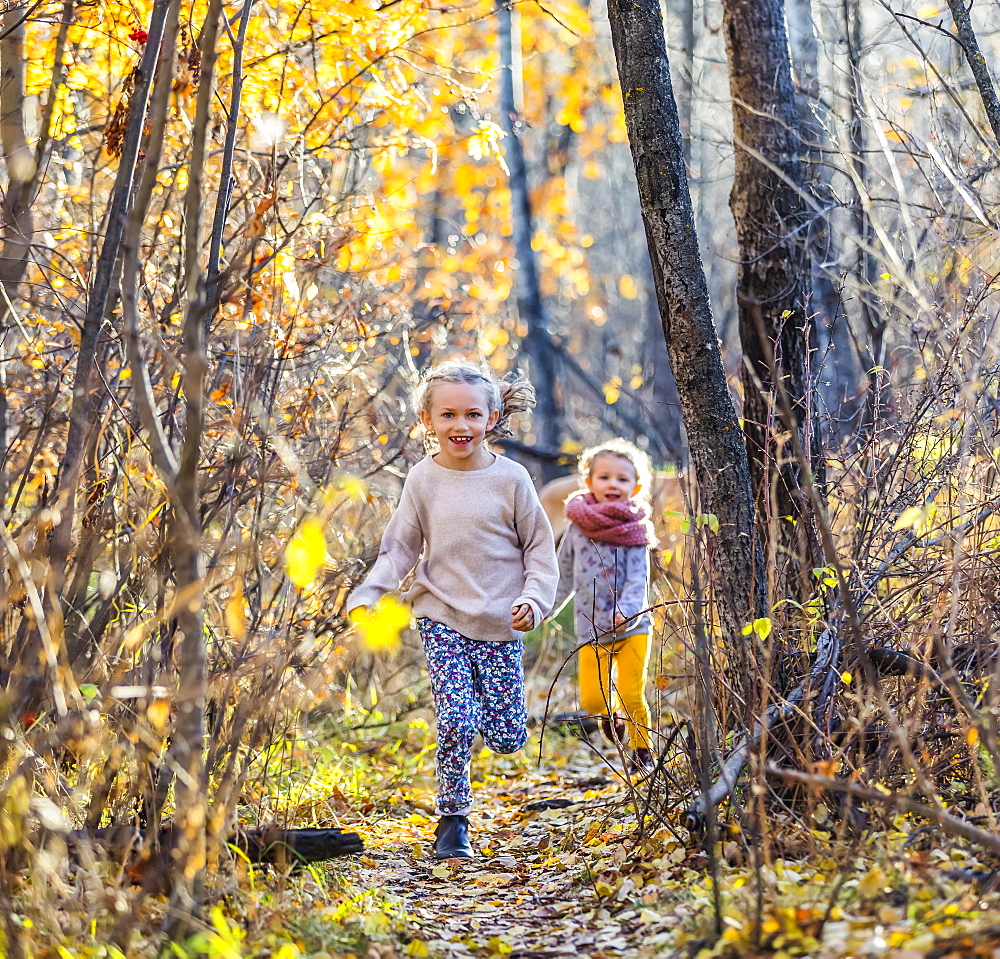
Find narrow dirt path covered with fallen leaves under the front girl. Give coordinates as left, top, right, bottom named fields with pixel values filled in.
left=340, top=738, right=667, bottom=959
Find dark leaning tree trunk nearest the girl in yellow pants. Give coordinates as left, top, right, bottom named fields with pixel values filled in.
left=608, top=0, right=767, bottom=715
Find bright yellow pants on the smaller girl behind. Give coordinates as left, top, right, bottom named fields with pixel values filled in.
left=579, top=633, right=650, bottom=749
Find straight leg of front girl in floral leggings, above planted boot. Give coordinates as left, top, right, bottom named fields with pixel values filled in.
left=417, top=619, right=481, bottom=816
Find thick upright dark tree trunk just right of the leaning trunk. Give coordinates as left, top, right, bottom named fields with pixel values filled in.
left=723, top=0, right=819, bottom=598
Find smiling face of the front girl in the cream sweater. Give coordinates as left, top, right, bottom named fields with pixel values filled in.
left=420, top=383, right=500, bottom=470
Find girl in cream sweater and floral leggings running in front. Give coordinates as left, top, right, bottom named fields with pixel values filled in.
left=347, top=360, right=559, bottom=859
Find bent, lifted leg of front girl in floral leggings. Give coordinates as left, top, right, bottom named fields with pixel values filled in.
left=469, top=639, right=528, bottom=753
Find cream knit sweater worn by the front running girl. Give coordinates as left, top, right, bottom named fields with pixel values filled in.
left=347, top=455, right=559, bottom=642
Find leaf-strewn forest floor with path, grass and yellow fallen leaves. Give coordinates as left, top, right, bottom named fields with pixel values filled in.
left=21, top=644, right=1000, bottom=959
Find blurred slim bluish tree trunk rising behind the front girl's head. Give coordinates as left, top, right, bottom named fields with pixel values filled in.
left=497, top=0, right=562, bottom=481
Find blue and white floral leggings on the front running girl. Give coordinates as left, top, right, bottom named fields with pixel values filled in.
left=417, top=618, right=528, bottom=816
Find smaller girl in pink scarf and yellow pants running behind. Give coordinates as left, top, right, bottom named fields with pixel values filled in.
left=556, top=439, right=655, bottom=778
